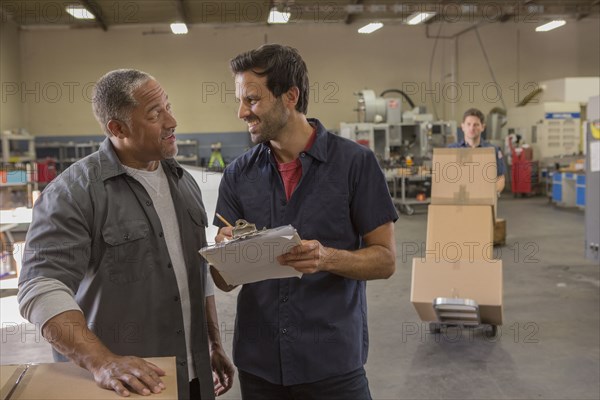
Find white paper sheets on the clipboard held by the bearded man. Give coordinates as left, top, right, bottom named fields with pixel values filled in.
left=199, top=225, right=302, bottom=285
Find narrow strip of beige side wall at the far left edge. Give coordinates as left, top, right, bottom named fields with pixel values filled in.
left=0, top=18, right=23, bottom=131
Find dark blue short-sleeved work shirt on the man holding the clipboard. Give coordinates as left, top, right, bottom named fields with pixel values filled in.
left=214, top=119, right=398, bottom=385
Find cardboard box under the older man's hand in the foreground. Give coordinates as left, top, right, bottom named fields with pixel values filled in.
left=0, top=357, right=177, bottom=400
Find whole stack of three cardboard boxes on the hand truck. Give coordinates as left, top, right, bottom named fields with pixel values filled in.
left=411, top=148, right=502, bottom=326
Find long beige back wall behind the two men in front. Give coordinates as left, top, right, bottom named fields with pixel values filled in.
left=11, top=19, right=600, bottom=135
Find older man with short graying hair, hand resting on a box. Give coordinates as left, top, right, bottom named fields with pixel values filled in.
left=18, top=69, right=234, bottom=399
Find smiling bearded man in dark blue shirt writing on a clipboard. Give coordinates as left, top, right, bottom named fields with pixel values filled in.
left=211, top=44, right=398, bottom=399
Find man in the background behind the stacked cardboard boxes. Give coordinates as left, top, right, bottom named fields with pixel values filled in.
left=448, top=108, right=505, bottom=193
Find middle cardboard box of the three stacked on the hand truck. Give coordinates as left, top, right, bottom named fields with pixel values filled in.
left=425, top=205, right=494, bottom=262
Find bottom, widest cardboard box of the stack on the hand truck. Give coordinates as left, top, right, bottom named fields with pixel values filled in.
left=410, top=258, right=502, bottom=325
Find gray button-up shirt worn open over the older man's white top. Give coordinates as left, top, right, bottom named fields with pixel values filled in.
left=19, top=139, right=214, bottom=399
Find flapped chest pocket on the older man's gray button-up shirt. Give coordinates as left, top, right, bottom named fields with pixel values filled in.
left=101, top=220, right=152, bottom=285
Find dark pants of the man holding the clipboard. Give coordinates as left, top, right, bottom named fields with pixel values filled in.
left=238, top=367, right=371, bottom=400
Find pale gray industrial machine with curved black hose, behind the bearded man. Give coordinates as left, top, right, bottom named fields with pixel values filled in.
left=340, top=89, right=456, bottom=167
